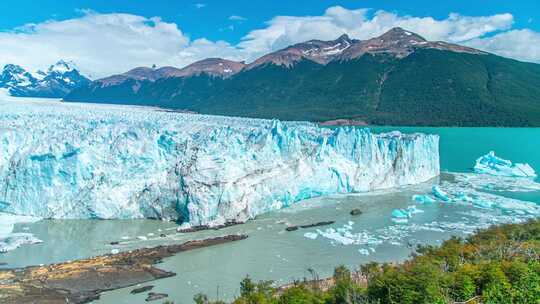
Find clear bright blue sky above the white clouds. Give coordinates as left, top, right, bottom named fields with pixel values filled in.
left=0, top=0, right=540, bottom=43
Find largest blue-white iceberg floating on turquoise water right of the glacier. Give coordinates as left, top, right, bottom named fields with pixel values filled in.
left=474, top=151, right=536, bottom=177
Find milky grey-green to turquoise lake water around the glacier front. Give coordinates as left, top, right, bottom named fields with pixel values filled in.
left=0, top=121, right=540, bottom=303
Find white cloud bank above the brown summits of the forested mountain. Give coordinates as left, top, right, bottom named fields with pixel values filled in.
left=240, top=6, right=513, bottom=52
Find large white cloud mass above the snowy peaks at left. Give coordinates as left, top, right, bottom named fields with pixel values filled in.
left=0, top=12, right=189, bottom=77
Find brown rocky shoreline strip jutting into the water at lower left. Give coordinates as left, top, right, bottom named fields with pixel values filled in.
left=0, top=235, right=247, bottom=304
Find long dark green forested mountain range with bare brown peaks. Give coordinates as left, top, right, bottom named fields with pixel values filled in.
left=64, top=28, right=540, bottom=126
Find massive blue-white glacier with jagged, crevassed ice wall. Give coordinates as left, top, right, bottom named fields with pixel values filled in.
left=0, top=101, right=439, bottom=225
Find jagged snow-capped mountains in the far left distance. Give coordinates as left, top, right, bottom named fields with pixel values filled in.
left=0, top=60, right=91, bottom=98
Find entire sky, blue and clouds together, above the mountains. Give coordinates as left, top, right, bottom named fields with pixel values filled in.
left=0, top=0, right=540, bottom=78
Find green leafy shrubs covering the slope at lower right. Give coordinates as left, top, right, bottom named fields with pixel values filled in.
left=194, top=220, right=540, bottom=304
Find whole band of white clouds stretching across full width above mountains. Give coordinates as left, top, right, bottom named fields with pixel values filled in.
left=0, top=6, right=540, bottom=77
